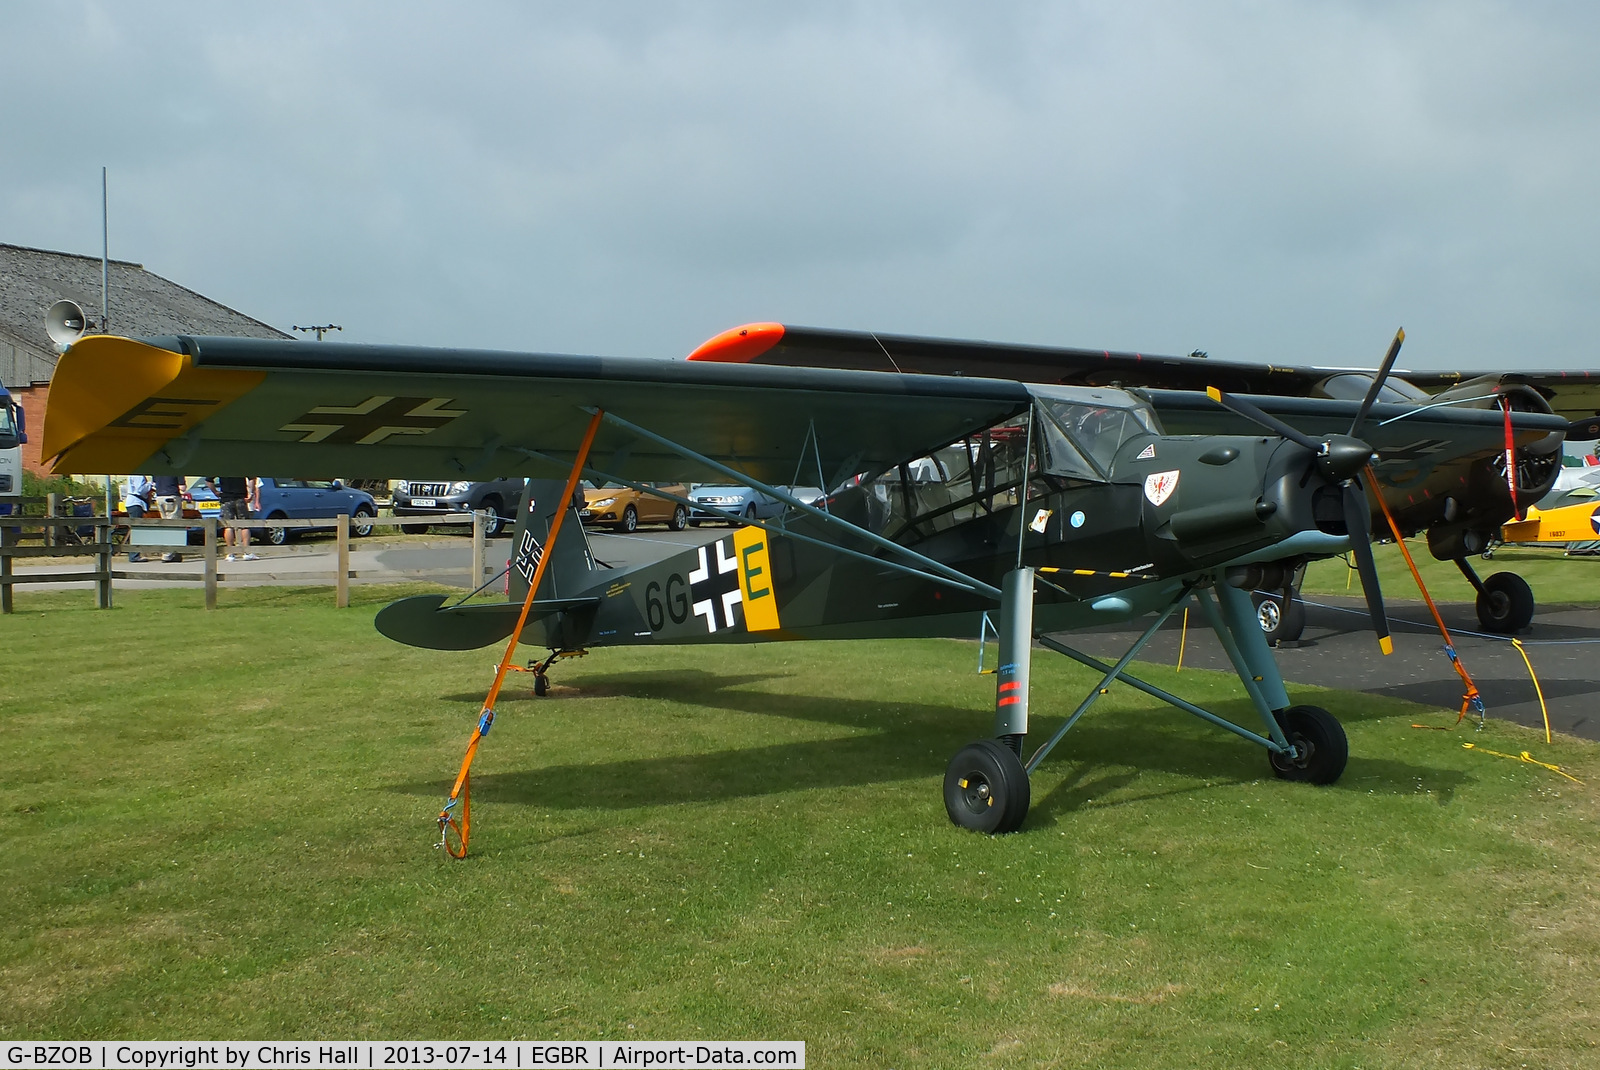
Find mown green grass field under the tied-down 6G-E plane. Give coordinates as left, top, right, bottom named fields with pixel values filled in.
left=0, top=589, right=1600, bottom=1067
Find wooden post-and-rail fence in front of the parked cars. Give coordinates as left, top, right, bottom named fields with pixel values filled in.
left=0, top=502, right=488, bottom=613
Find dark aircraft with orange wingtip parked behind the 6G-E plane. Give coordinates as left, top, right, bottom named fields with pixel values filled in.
left=690, top=323, right=1600, bottom=638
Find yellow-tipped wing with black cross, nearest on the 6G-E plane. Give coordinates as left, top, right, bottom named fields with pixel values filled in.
left=43, top=336, right=1030, bottom=483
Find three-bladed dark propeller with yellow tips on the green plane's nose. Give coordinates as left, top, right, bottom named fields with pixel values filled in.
left=1206, top=328, right=1405, bottom=654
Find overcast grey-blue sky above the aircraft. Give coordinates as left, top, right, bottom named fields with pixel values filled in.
left=0, top=0, right=1600, bottom=369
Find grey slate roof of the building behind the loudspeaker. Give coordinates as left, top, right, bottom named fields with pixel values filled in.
left=0, top=243, right=290, bottom=385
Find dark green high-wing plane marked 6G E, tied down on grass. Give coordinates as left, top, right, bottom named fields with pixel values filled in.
left=43, top=336, right=1566, bottom=852
